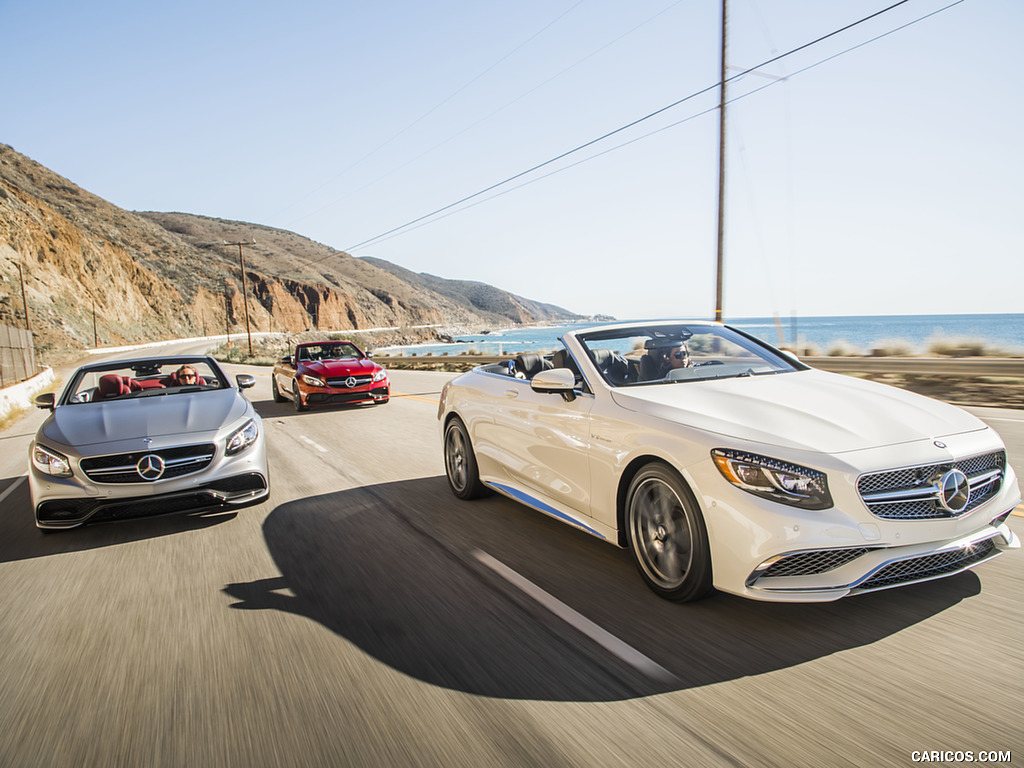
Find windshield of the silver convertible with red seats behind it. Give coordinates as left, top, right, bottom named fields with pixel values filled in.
left=62, top=358, right=229, bottom=404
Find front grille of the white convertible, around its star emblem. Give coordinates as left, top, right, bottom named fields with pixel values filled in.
left=857, top=451, right=1007, bottom=520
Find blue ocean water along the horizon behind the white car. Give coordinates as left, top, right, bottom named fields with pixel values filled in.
left=379, top=314, right=1024, bottom=355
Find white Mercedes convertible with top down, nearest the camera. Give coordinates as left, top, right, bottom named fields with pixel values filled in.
left=438, top=322, right=1021, bottom=602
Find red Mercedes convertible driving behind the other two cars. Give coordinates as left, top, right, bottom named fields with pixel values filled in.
left=271, top=341, right=390, bottom=411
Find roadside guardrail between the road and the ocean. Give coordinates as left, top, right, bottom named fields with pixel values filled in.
left=374, top=354, right=1024, bottom=378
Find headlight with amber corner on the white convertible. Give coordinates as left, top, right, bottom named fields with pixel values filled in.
left=711, top=449, right=833, bottom=509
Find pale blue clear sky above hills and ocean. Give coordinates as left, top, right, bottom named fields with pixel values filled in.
left=0, top=0, right=1024, bottom=319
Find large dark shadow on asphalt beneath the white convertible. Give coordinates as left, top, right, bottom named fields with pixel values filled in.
left=224, top=477, right=980, bottom=701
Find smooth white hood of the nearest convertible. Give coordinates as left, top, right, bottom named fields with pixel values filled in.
left=611, top=370, right=987, bottom=454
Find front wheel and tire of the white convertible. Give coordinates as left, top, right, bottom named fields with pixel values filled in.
left=626, top=463, right=714, bottom=602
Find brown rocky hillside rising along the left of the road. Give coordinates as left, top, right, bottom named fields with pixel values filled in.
left=0, top=144, right=579, bottom=358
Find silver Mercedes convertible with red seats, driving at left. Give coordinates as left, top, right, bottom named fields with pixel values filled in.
left=29, top=355, right=270, bottom=530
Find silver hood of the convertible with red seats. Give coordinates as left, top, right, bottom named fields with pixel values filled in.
left=42, top=389, right=249, bottom=446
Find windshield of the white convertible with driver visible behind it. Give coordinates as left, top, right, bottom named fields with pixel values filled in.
left=578, top=324, right=806, bottom=387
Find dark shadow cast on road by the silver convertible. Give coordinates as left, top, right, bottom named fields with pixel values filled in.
left=0, top=476, right=238, bottom=563
